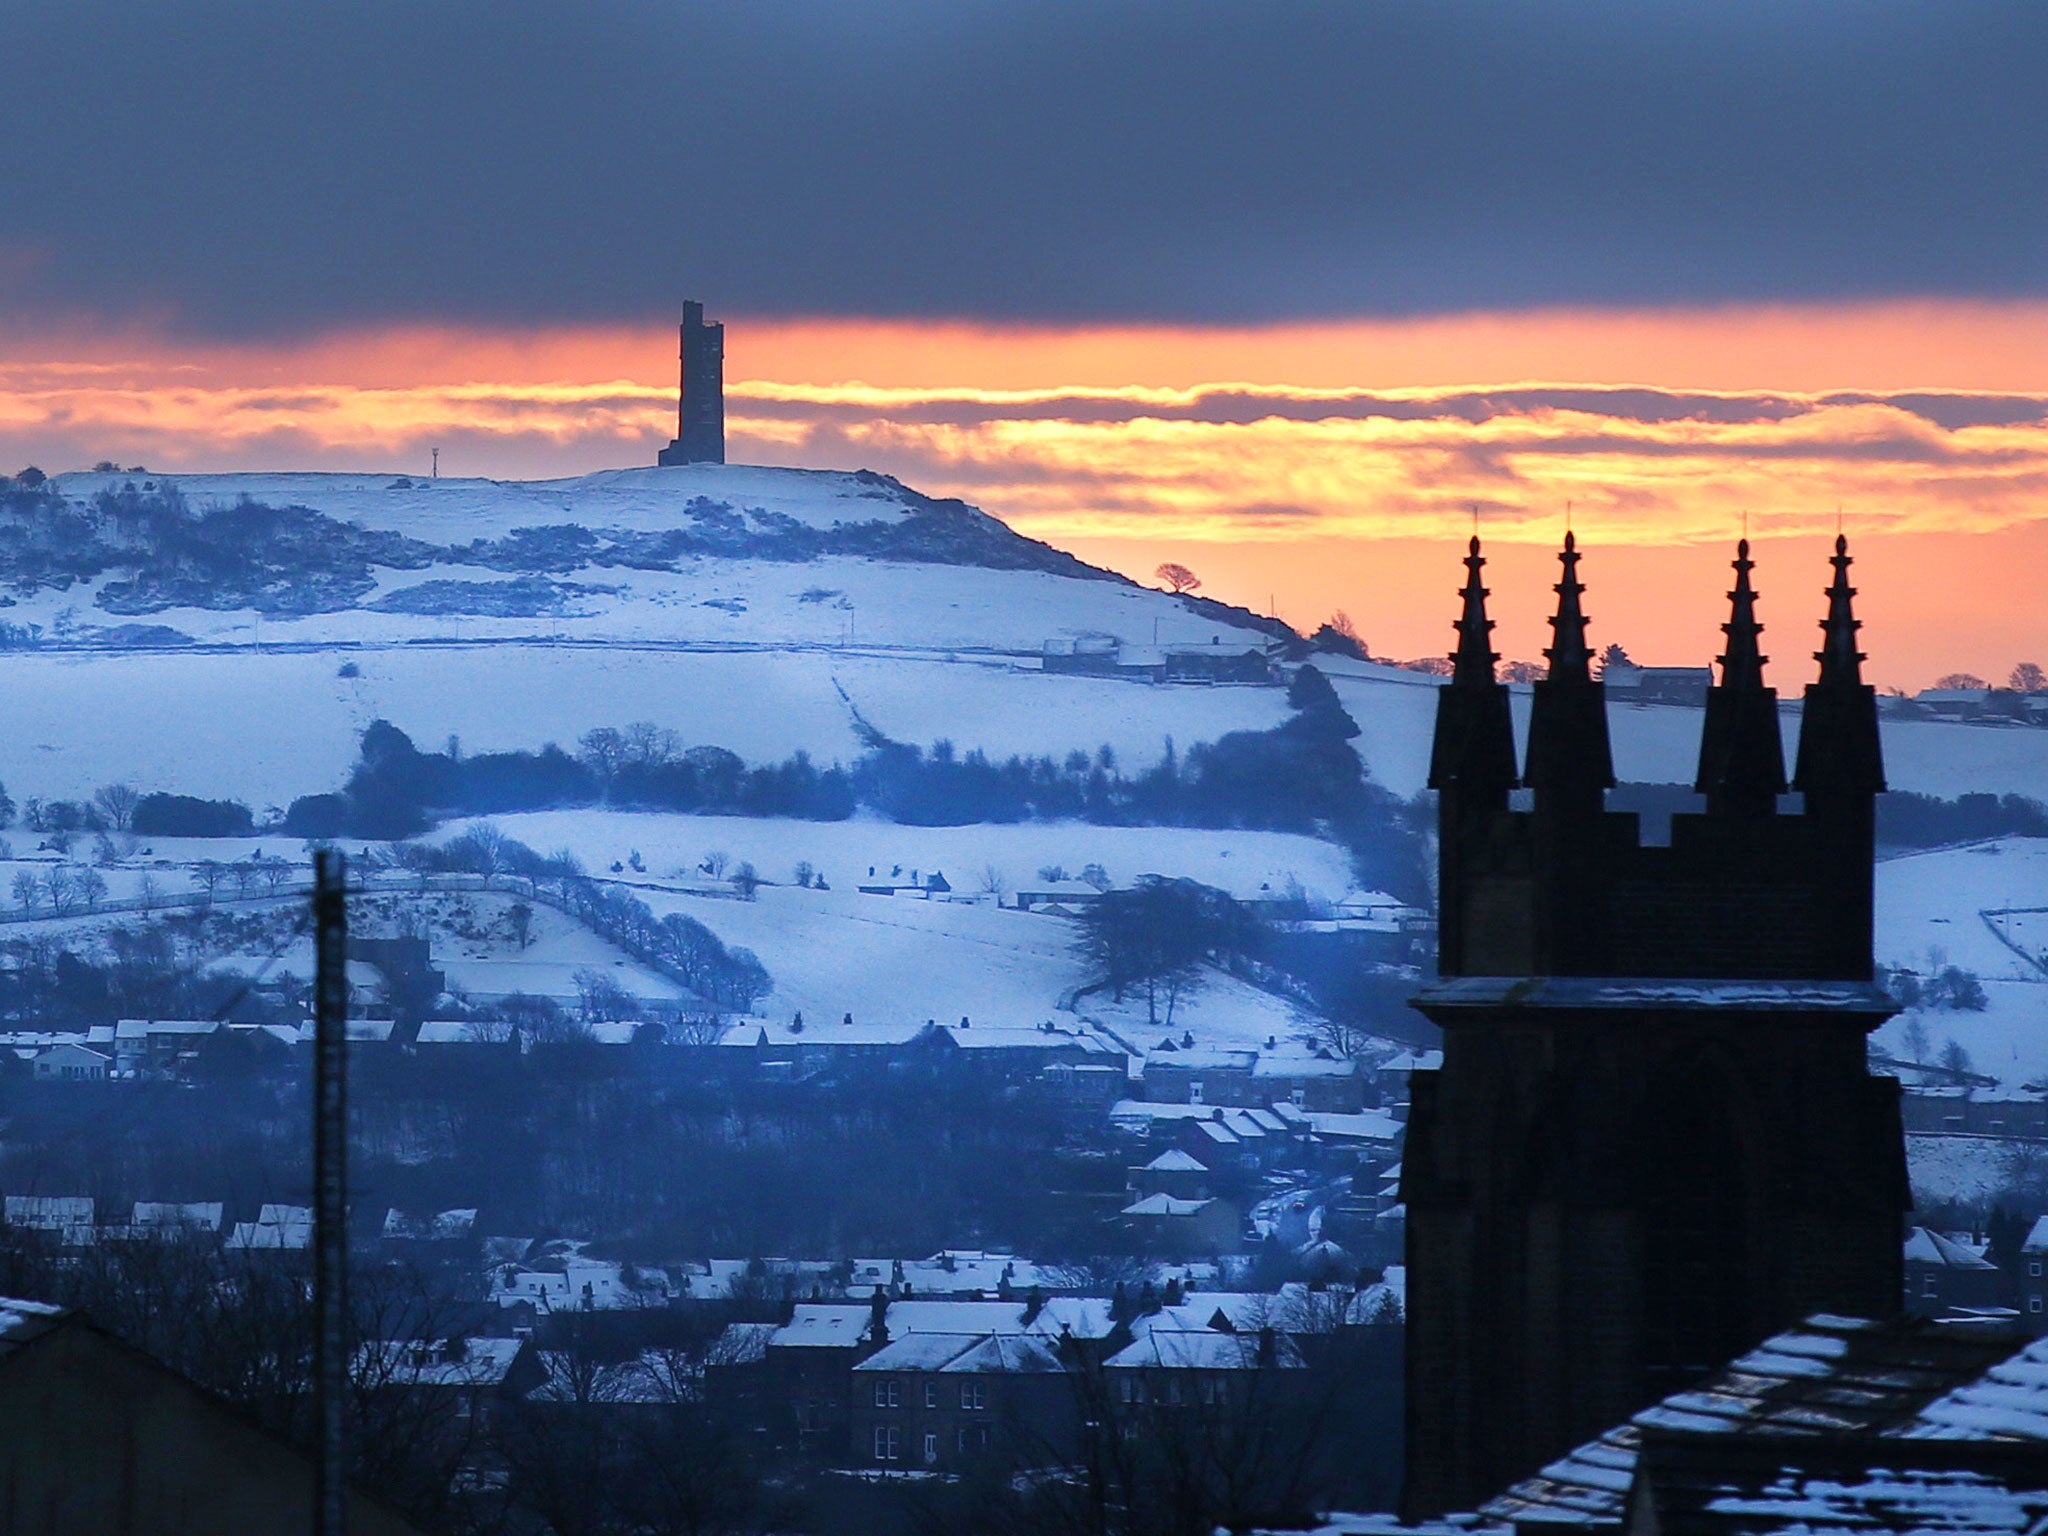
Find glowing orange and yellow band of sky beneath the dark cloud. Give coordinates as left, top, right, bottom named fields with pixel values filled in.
left=0, top=303, right=2048, bottom=682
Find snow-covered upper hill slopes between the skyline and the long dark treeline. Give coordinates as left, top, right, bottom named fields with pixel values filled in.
left=0, top=465, right=2048, bottom=831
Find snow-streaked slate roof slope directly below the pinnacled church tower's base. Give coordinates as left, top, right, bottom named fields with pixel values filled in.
left=1479, top=1313, right=2013, bottom=1524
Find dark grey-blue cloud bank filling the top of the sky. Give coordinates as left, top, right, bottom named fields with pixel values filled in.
left=0, top=0, right=2048, bottom=334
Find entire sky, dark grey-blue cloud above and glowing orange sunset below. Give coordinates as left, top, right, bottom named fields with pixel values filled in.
left=0, top=0, right=2048, bottom=686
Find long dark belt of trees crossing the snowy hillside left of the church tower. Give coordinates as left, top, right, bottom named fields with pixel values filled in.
left=285, top=666, right=1425, bottom=895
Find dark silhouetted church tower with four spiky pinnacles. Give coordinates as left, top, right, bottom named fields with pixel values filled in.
left=1401, top=535, right=1907, bottom=1518
